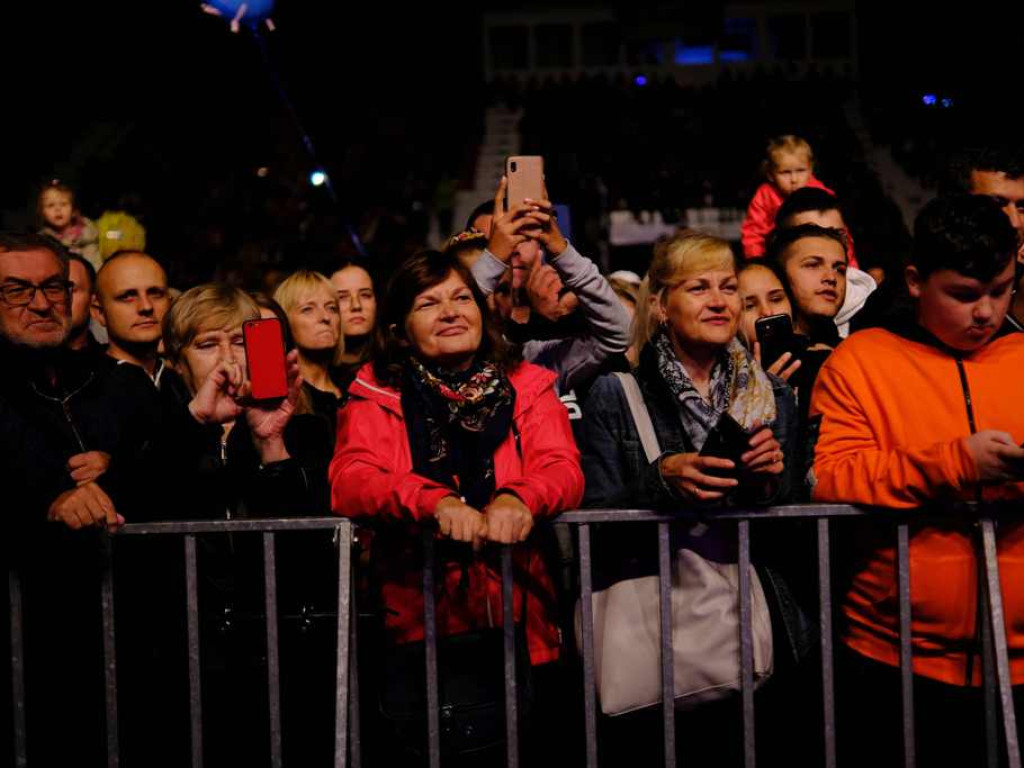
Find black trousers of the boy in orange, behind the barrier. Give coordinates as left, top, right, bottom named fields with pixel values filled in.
left=836, top=646, right=1024, bottom=768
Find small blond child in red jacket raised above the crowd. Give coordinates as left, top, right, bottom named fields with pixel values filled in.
left=742, top=134, right=835, bottom=259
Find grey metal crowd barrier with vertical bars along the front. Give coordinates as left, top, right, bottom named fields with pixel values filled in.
left=8, top=505, right=1021, bottom=768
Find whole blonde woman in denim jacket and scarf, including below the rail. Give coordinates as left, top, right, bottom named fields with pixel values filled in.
left=581, top=231, right=805, bottom=766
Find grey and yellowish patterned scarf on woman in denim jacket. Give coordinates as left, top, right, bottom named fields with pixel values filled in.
left=651, top=330, right=775, bottom=451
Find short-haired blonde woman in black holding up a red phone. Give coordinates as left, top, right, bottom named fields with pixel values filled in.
left=154, top=284, right=337, bottom=764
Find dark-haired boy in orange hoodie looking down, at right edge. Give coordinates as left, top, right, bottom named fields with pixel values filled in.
left=811, top=196, right=1024, bottom=766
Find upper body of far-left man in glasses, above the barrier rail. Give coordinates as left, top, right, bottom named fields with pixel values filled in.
left=0, top=233, right=154, bottom=529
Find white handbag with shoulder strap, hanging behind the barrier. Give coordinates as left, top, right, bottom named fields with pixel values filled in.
left=575, top=374, right=773, bottom=715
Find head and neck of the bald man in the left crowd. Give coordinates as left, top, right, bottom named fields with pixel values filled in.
left=92, top=251, right=171, bottom=386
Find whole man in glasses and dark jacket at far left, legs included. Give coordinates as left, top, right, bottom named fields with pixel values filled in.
left=0, top=233, right=166, bottom=765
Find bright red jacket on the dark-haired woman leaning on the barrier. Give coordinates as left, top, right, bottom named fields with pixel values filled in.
left=329, top=362, right=584, bottom=664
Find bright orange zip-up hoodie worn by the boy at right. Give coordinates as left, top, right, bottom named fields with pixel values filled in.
left=811, top=329, right=1024, bottom=685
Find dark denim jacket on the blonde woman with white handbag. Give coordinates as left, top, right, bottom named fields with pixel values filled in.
left=581, top=347, right=813, bottom=658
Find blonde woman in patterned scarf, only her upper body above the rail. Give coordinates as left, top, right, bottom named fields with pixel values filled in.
left=584, top=232, right=795, bottom=506
